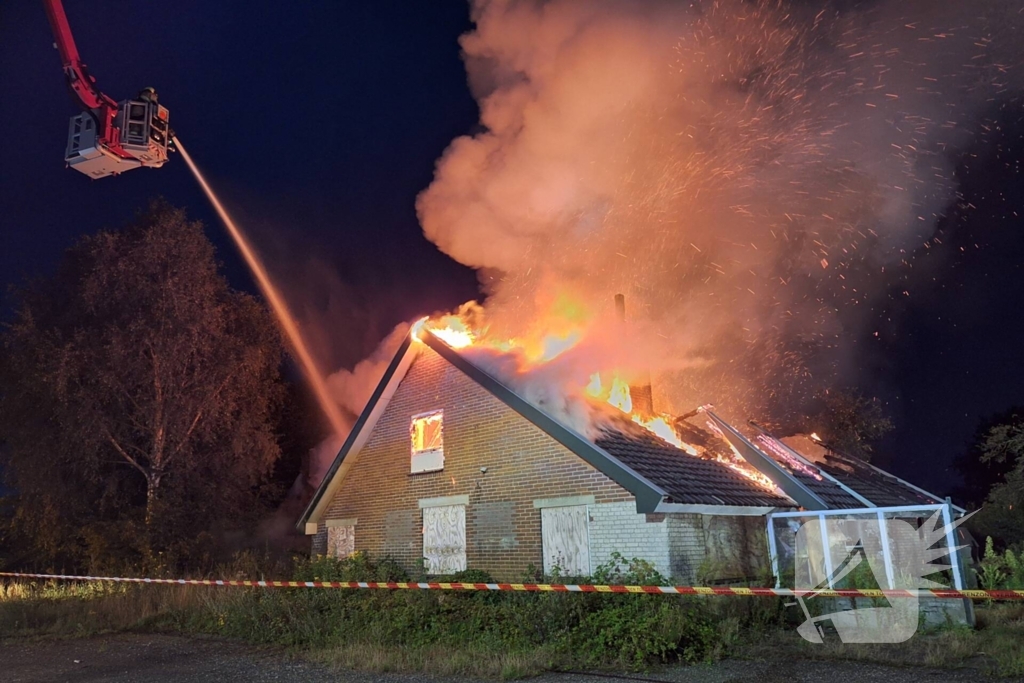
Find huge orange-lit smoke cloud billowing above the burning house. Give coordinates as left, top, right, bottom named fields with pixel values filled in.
left=417, top=0, right=1021, bottom=417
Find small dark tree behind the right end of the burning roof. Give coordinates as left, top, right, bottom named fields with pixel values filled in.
left=811, top=390, right=893, bottom=460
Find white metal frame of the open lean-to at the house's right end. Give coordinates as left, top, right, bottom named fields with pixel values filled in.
left=766, top=502, right=966, bottom=591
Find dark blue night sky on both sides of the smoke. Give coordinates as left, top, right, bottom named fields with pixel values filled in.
left=0, top=0, right=1024, bottom=493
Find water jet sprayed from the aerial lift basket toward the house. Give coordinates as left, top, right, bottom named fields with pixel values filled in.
left=174, top=138, right=348, bottom=436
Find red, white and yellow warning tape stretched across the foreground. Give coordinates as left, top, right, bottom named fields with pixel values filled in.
left=0, top=571, right=1024, bottom=600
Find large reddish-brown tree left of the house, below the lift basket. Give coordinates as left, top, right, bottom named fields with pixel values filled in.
left=0, top=203, right=283, bottom=564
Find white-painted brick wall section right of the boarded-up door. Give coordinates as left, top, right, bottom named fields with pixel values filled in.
left=588, top=501, right=672, bottom=577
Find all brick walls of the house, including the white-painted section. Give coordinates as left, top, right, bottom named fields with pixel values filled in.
left=312, top=346, right=767, bottom=581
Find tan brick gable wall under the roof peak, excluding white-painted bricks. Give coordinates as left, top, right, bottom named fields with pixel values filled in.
left=313, top=347, right=635, bottom=580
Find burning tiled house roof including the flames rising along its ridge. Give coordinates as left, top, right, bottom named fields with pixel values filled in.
left=300, top=317, right=958, bottom=525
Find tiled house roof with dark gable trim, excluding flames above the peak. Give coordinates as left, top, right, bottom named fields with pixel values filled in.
left=297, top=330, right=961, bottom=529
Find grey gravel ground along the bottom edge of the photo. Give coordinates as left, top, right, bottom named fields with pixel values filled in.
left=0, top=634, right=1009, bottom=683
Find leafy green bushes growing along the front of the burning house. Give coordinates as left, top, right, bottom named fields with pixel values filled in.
left=172, top=553, right=721, bottom=671
